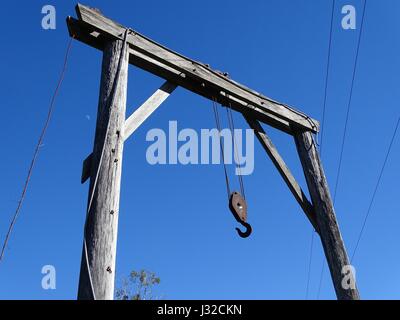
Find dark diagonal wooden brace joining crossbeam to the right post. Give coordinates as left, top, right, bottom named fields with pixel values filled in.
left=245, top=117, right=319, bottom=232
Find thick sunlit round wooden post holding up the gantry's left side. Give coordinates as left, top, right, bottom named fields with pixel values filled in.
left=78, top=40, right=128, bottom=300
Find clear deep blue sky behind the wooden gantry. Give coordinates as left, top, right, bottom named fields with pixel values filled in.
left=0, top=0, right=400, bottom=299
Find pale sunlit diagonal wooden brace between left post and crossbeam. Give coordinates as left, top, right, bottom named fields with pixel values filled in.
left=123, top=81, right=176, bottom=141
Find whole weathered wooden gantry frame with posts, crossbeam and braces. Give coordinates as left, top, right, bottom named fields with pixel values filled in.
left=67, top=4, right=359, bottom=300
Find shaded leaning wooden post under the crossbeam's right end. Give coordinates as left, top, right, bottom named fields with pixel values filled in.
left=294, top=131, right=360, bottom=300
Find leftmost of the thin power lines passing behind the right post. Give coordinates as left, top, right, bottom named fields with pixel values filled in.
left=306, top=0, right=336, bottom=299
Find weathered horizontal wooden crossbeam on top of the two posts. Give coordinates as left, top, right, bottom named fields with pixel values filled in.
left=67, top=4, right=319, bottom=134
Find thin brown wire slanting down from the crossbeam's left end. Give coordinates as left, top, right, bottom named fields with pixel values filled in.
left=0, top=37, right=73, bottom=261
